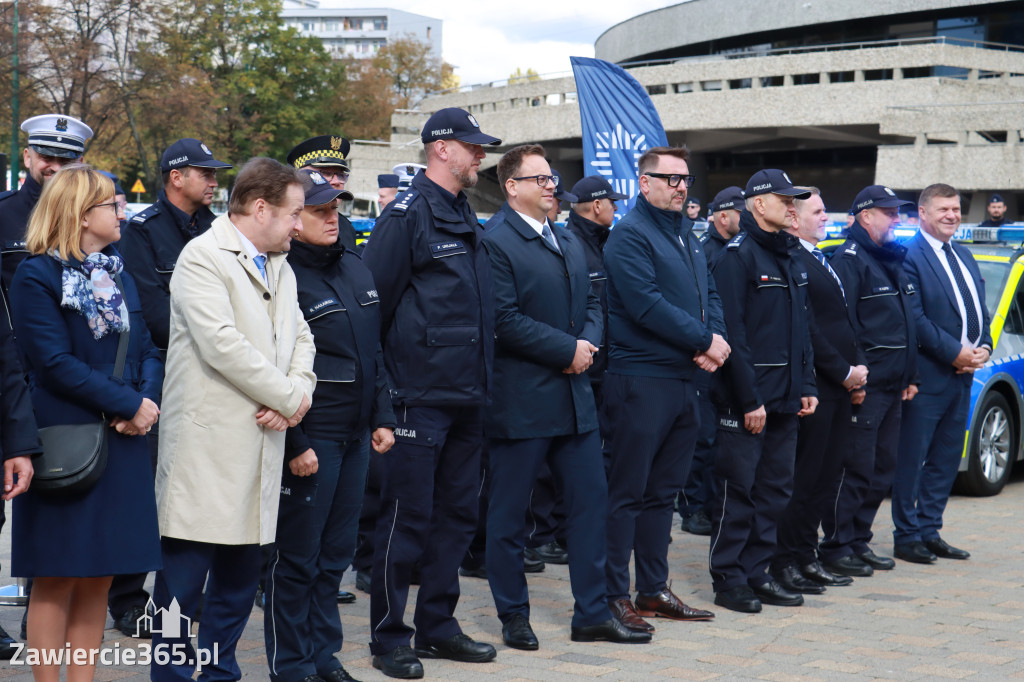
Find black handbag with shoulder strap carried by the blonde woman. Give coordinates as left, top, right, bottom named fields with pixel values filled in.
left=31, top=275, right=129, bottom=495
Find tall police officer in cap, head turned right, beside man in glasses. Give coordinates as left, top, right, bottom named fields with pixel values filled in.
left=364, top=108, right=501, bottom=678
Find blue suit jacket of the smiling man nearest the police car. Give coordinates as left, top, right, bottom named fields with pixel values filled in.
left=903, top=232, right=992, bottom=393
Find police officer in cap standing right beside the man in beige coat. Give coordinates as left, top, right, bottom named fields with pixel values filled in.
left=263, top=168, right=394, bottom=682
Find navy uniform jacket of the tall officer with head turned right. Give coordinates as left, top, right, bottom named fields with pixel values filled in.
left=362, top=173, right=495, bottom=406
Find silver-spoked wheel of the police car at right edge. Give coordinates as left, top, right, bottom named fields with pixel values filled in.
left=959, top=391, right=1018, bottom=497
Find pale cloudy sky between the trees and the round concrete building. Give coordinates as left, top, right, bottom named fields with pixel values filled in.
left=321, top=0, right=679, bottom=85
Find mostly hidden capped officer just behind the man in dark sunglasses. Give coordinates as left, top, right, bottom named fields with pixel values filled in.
left=676, top=185, right=745, bottom=536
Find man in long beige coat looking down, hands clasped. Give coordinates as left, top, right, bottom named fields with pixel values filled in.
left=151, top=159, right=315, bottom=682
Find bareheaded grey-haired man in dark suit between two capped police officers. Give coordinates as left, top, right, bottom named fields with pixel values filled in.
left=771, top=187, right=867, bottom=594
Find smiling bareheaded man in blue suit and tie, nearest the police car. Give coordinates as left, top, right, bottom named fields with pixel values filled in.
left=892, top=184, right=992, bottom=563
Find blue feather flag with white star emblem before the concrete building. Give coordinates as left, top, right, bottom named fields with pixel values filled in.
left=569, top=57, right=669, bottom=211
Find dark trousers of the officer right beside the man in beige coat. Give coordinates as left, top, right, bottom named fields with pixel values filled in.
left=263, top=433, right=370, bottom=682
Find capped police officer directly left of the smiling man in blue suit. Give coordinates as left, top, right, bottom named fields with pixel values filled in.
left=818, top=184, right=919, bottom=578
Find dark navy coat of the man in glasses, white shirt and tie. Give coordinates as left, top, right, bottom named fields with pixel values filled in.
left=479, top=205, right=601, bottom=438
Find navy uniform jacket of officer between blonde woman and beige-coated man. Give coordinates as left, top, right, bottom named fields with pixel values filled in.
left=118, top=189, right=217, bottom=352
